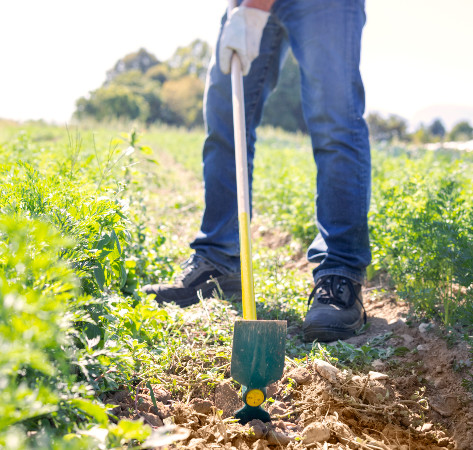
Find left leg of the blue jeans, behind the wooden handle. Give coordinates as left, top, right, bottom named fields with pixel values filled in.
left=191, top=16, right=288, bottom=273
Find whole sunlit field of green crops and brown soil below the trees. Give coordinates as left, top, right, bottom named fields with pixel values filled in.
left=0, top=122, right=473, bottom=450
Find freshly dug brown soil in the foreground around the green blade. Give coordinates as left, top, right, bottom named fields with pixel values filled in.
left=104, top=288, right=473, bottom=450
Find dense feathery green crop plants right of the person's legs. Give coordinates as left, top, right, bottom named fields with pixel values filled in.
left=371, top=152, right=473, bottom=325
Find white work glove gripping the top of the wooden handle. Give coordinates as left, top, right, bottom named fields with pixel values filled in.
left=219, top=6, right=270, bottom=75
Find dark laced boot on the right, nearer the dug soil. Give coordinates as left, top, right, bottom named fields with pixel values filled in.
left=302, top=275, right=366, bottom=342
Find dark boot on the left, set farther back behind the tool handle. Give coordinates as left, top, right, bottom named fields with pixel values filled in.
left=142, top=254, right=241, bottom=307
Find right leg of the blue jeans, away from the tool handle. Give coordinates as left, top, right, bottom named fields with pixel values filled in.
left=275, top=0, right=371, bottom=282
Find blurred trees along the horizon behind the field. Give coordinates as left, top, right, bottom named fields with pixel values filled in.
left=74, top=39, right=473, bottom=143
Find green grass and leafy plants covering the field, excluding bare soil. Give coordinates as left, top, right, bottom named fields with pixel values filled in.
left=0, top=122, right=473, bottom=449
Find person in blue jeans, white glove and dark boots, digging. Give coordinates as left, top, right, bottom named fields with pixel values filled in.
left=143, top=0, right=371, bottom=342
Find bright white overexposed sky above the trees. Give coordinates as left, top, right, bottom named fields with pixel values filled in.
left=0, top=0, right=473, bottom=127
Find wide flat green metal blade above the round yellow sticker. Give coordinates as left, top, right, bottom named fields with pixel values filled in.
left=231, top=320, right=287, bottom=388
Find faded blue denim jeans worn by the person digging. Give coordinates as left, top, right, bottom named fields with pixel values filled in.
left=191, top=0, right=371, bottom=282
